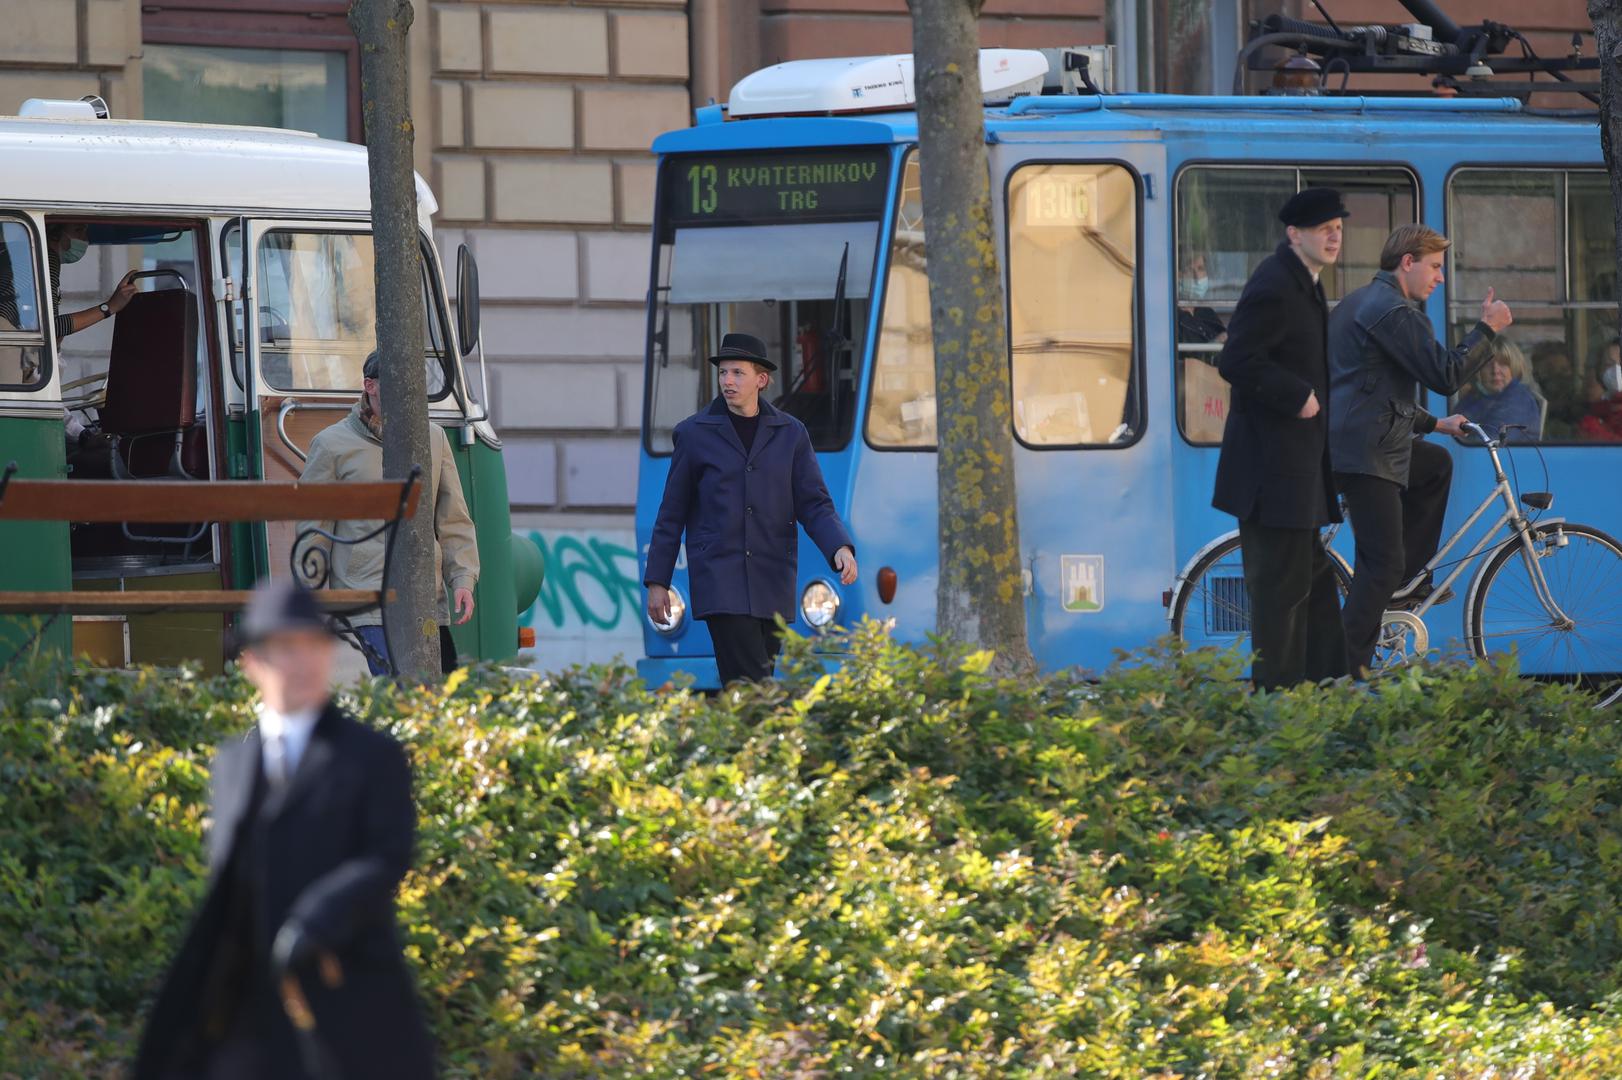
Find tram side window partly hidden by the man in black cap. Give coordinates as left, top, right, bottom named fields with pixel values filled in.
left=1176, top=165, right=1418, bottom=446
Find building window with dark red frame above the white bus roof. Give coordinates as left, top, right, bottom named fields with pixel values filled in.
left=141, top=0, right=363, bottom=143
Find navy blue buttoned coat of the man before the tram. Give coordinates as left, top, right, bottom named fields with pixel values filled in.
left=642, top=397, right=853, bottom=623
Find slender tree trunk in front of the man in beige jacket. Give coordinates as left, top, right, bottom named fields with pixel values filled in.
left=349, top=0, right=440, bottom=681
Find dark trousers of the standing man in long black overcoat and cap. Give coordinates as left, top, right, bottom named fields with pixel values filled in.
left=1239, top=521, right=1346, bottom=689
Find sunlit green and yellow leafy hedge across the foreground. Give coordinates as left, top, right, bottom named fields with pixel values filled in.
left=0, top=628, right=1622, bottom=1080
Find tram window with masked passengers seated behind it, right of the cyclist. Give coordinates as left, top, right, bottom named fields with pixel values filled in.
left=1447, top=169, right=1622, bottom=443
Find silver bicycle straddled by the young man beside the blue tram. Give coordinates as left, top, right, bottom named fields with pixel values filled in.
left=1169, top=423, right=1622, bottom=707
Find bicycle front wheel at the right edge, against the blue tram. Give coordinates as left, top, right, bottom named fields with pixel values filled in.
left=1465, top=522, right=1622, bottom=707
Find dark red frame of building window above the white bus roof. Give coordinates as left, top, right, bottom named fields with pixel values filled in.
left=141, top=0, right=367, bottom=144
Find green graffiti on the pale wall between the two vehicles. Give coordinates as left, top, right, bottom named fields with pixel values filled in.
left=519, top=532, right=642, bottom=631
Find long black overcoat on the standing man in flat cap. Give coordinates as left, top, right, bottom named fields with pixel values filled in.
left=1212, top=243, right=1340, bottom=529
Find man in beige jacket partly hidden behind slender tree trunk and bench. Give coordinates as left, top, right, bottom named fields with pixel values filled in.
left=298, top=352, right=478, bottom=675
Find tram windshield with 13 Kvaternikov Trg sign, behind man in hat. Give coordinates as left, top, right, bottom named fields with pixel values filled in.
left=647, top=148, right=890, bottom=454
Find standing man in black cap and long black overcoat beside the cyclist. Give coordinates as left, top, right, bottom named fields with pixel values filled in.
left=1212, top=188, right=1346, bottom=689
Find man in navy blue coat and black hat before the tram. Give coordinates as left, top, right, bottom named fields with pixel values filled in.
left=642, top=334, right=856, bottom=686
